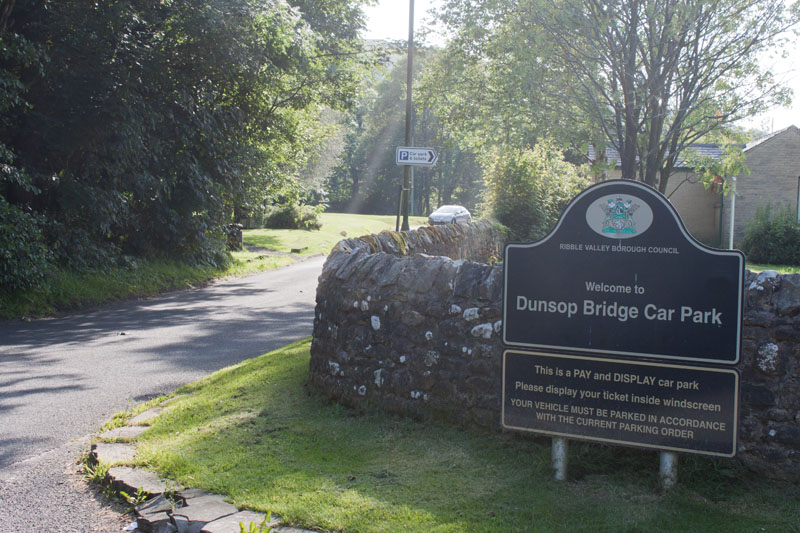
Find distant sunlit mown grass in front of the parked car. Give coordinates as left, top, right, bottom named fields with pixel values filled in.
left=244, top=213, right=427, bottom=254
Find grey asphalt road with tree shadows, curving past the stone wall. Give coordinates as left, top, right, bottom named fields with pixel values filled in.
left=0, top=257, right=324, bottom=533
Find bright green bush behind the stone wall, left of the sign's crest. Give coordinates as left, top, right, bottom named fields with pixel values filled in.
left=484, top=141, right=589, bottom=240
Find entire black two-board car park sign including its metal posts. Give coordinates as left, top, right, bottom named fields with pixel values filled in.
left=502, top=180, right=744, bottom=488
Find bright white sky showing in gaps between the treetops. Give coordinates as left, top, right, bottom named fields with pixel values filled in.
left=364, top=0, right=800, bottom=133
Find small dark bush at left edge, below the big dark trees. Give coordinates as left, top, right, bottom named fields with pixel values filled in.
left=0, top=196, right=52, bottom=291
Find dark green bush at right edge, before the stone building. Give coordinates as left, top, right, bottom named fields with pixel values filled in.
left=739, top=205, right=800, bottom=265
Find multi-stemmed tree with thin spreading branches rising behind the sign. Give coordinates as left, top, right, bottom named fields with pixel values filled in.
left=519, top=0, right=798, bottom=192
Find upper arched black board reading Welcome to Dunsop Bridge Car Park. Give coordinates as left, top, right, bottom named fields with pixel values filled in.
left=503, top=180, right=744, bottom=364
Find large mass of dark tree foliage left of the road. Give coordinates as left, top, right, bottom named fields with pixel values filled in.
left=0, top=0, right=371, bottom=269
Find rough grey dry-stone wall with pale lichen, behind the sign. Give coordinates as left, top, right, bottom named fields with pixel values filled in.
left=309, top=223, right=800, bottom=480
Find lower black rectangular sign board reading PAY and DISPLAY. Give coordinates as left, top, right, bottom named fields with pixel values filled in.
left=502, top=350, right=739, bottom=457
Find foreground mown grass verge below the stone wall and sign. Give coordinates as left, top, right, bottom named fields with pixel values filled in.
left=134, top=340, right=800, bottom=532
